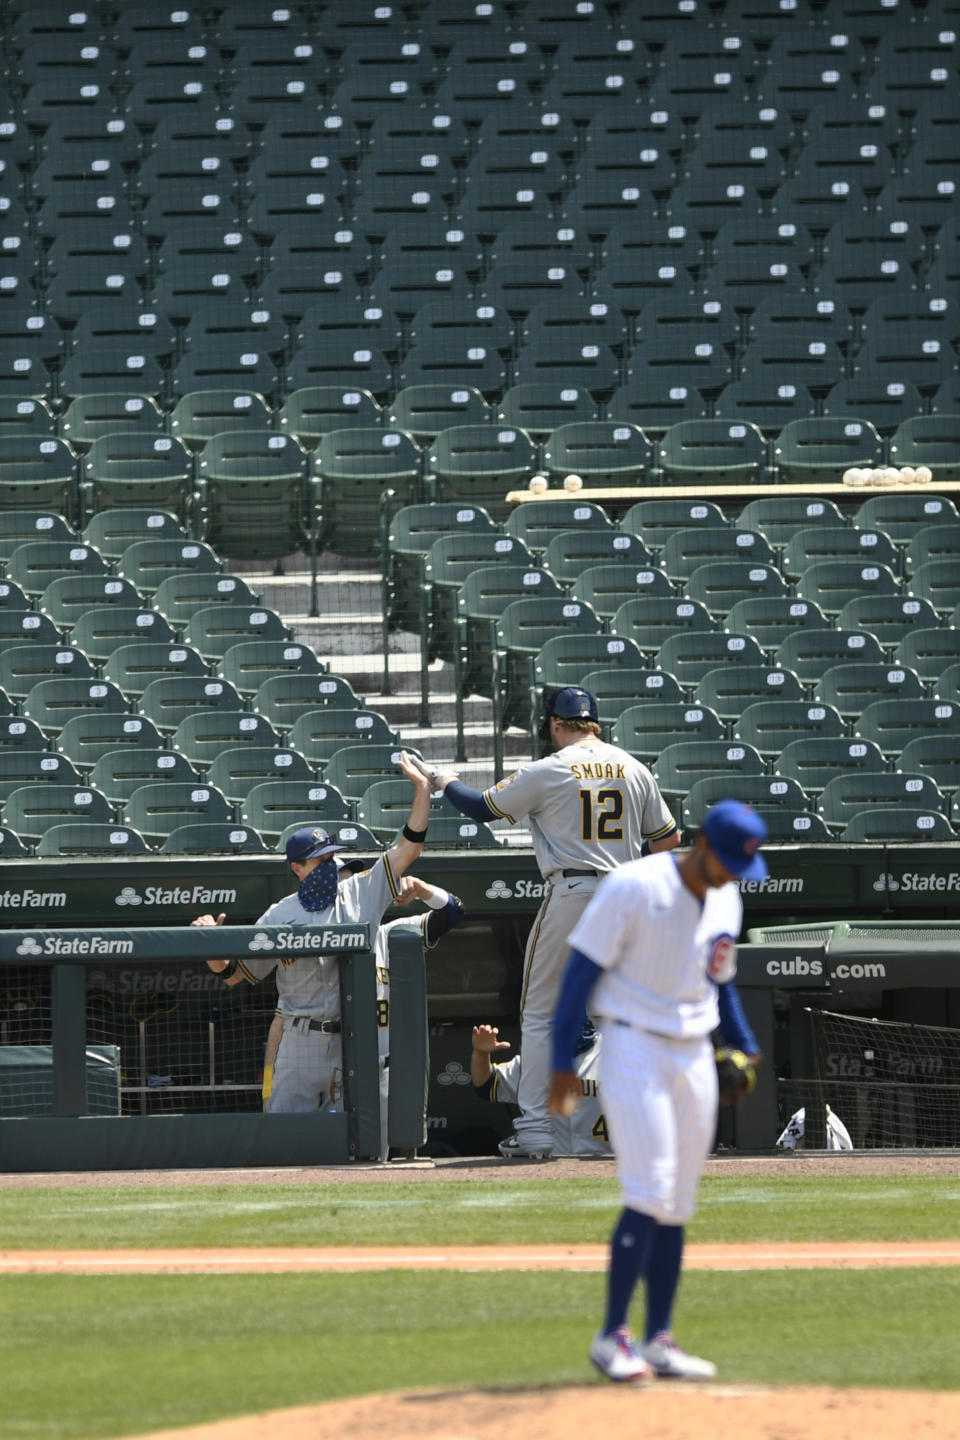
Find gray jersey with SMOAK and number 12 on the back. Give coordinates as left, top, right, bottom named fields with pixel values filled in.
left=484, top=736, right=674, bottom=878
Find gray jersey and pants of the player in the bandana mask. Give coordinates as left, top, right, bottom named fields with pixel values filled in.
left=244, top=851, right=400, bottom=1113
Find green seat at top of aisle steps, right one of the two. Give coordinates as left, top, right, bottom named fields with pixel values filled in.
left=311, top=426, right=422, bottom=554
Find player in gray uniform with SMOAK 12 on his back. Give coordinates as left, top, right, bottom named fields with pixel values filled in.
left=415, top=685, right=679, bottom=1159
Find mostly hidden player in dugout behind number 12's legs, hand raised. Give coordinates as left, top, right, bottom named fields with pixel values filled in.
left=471, top=1021, right=613, bottom=1159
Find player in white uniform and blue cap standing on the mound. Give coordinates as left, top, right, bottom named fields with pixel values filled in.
left=550, top=801, right=767, bottom=1381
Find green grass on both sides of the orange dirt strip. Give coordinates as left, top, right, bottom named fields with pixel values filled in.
left=0, top=1174, right=960, bottom=1440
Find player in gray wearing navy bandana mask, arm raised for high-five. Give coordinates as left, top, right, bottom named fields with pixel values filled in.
left=193, top=752, right=430, bottom=1112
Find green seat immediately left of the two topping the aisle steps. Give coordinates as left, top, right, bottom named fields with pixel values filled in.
left=79, top=432, right=193, bottom=521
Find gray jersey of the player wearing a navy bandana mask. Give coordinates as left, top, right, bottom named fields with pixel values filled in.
left=237, top=851, right=399, bottom=1020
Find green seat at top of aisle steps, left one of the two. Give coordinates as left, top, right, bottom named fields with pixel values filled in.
left=197, top=429, right=320, bottom=576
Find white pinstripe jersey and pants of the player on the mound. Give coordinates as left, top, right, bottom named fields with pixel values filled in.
left=570, top=854, right=743, bottom=1225
